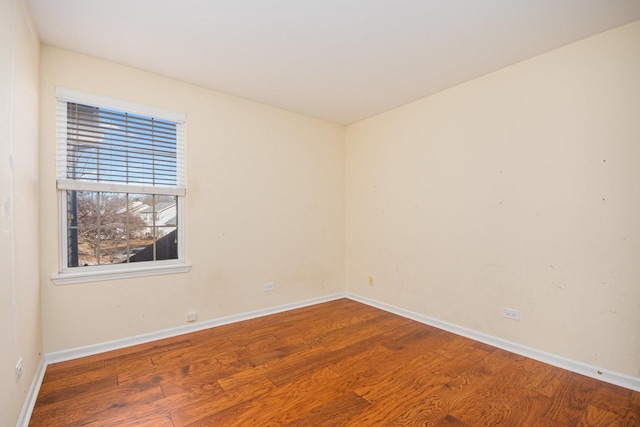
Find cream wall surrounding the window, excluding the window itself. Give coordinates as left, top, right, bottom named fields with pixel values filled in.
left=40, top=46, right=345, bottom=352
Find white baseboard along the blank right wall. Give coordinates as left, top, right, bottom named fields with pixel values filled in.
left=346, top=293, right=640, bottom=391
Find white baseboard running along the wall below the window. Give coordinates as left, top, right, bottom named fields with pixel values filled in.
left=45, top=293, right=346, bottom=364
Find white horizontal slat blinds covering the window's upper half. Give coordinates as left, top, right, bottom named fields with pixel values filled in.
left=57, top=90, right=185, bottom=196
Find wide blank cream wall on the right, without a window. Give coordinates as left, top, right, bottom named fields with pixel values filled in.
left=346, top=22, right=640, bottom=376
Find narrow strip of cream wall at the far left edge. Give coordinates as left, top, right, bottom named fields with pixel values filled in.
left=0, top=0, right=42, bottom=426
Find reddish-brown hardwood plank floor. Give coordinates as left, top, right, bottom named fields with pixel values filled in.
left=30, top=299, right=640, bottom=427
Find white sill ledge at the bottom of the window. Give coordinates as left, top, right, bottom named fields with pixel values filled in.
left=51, top=262, right=191, bottom=285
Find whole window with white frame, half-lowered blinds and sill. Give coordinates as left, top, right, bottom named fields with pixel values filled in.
left=54, top=89, right=188, bottom=284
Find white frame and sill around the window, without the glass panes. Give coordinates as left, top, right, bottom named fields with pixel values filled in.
left=51, top=87, right=191, bottom=285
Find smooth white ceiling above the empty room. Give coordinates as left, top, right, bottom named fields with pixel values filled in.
left=28, top=0, right=640, bottom=124
